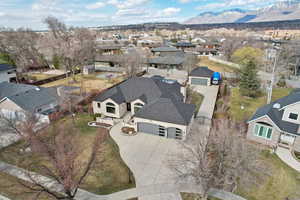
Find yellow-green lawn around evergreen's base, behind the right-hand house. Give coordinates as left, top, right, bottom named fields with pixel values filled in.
left=229, top=88, right=293, bottom=121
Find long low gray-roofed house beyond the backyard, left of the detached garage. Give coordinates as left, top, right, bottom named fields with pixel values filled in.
left=148, top=56, right=184, bottom=70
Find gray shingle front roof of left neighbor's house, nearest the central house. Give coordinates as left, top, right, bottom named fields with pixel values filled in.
left=8, top=88, right=57, bottom=112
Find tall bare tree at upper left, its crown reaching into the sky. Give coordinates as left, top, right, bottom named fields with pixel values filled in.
left=40, top=17, right=96, bottom=80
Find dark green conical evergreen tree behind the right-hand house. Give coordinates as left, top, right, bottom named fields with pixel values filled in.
left=240, top=61, right=260, bottom=97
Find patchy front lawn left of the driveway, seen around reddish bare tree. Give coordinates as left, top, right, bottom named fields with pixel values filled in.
left=0, top=114, right=135, bottom=194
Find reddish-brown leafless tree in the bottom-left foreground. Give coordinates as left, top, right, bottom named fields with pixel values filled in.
left=1, top=111, right=107, bottom=200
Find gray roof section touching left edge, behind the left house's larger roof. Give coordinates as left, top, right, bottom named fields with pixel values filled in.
left=0, top=82, right=37, bottom=100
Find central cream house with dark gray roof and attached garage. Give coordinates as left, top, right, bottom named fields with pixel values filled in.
left=93, top=76, right=195, bottom=139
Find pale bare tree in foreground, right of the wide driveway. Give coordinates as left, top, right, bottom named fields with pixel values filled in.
left=169, top=120, right=259, bottom=200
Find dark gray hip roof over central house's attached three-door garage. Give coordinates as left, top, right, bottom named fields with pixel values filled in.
left=135, top=98, right=196, bottom=125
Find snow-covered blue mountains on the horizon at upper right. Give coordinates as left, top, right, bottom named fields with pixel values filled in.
left=184, top=0, right=300, bottom=24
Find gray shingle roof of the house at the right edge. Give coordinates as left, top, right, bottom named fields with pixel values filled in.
left=249, top=91, right=300, bottom=135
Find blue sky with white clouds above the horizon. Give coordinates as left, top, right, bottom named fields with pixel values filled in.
left=0, top=0, right=292, bottom=29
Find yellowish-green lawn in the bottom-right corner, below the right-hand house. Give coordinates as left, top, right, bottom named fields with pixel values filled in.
left=237, top=151, right=300, bottom=200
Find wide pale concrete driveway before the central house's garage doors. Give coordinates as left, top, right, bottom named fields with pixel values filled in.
left=110, top=123, right=181, bottom=200
